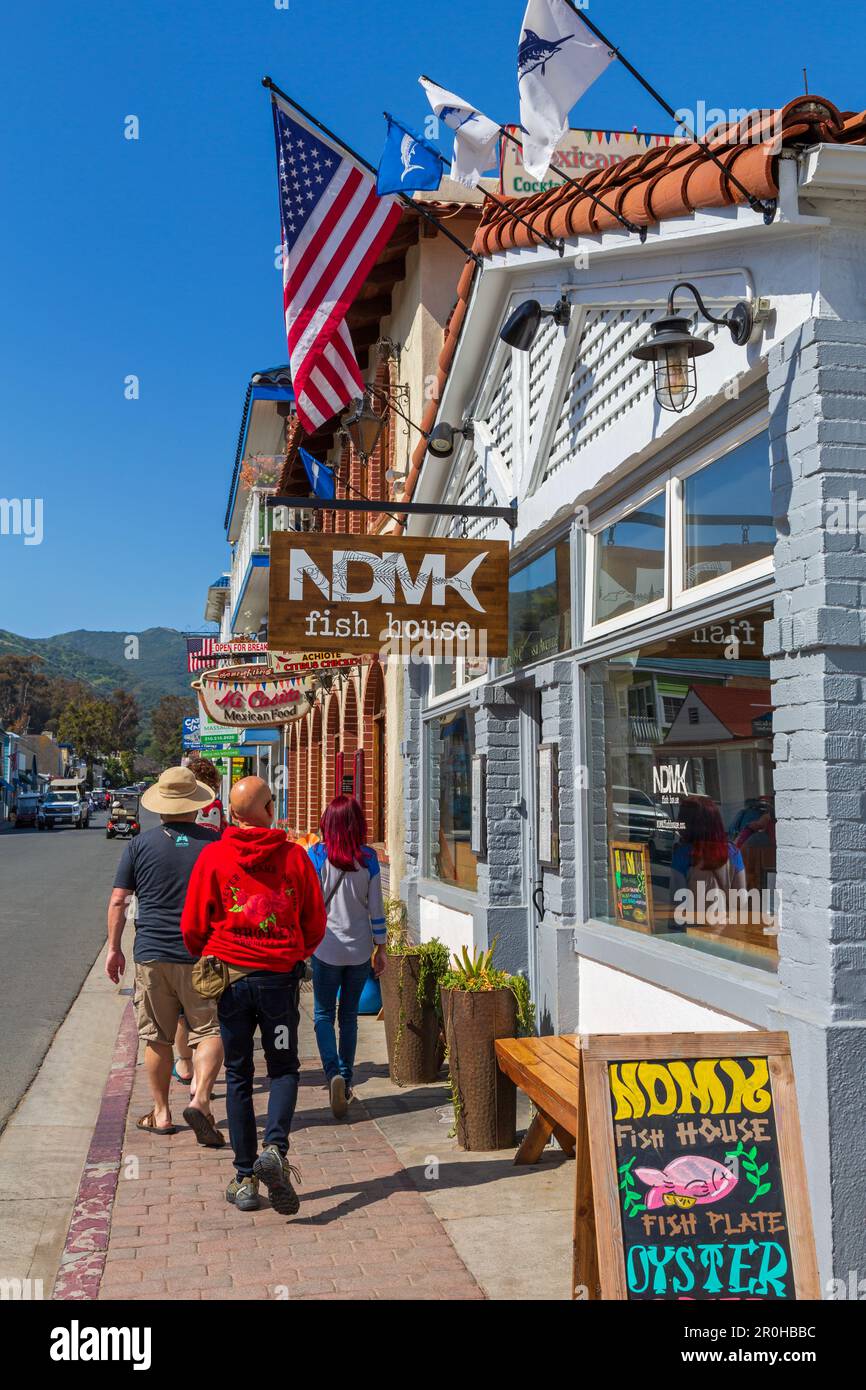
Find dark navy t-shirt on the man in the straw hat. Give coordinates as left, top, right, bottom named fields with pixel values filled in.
left=114, top=821, right=217, bottom=965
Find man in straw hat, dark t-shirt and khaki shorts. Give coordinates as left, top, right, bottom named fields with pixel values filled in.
left=106, top=767, right=225, bottom=1148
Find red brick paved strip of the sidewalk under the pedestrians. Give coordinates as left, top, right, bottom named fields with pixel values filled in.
left=97, top=994, right=484, bottom=1300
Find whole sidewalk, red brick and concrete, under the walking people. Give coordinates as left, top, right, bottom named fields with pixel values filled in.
left=54, top=991, right=574, bottom=1300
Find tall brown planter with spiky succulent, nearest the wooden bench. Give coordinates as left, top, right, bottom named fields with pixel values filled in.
left=441, top=941, right=535, bottom=1150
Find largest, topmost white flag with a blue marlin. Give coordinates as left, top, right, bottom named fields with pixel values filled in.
left=517, top=0, right=614, bottom=178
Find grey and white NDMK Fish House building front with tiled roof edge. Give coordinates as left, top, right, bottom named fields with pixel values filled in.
left=403, top=99, right=866, bottom=1280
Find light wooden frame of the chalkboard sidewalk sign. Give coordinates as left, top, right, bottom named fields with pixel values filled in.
left=573, top=1031, right=820, bottom=1301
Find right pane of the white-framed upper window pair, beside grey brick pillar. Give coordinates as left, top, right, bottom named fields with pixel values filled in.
left=683, top=431, right=776, bottom=589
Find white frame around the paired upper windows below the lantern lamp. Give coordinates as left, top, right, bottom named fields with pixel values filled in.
left=584, top=411, right=773, bottom=641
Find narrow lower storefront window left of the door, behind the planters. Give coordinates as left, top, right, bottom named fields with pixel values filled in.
left=427, top=709, right=478, bottom=892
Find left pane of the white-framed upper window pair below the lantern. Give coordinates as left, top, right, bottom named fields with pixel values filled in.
left=594, top=492, right=667, bottom=623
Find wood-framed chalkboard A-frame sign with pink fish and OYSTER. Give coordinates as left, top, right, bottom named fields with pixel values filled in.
left=574, top=1033, right=820, bottom=1301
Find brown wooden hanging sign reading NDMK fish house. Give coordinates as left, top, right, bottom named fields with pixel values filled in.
left=268, top=531, right=509, bottom=656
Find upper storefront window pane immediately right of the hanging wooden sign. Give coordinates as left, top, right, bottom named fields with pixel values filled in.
left=505, top=539, right=571, bottom=670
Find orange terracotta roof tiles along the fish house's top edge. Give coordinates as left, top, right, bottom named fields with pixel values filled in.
left=475, top=96, right=866, bottom=256
